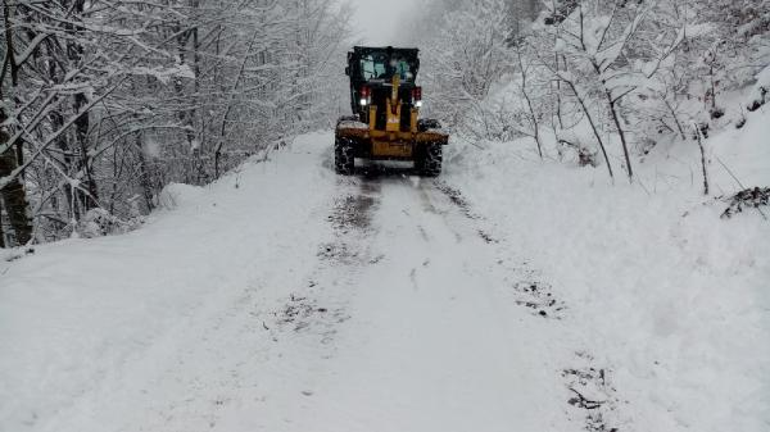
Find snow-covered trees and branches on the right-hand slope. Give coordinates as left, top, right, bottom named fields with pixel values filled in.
left=400, top=0, right=770, bottom=184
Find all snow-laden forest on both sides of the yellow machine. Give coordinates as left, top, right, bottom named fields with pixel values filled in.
left=0, top=0, right=770, bottom=247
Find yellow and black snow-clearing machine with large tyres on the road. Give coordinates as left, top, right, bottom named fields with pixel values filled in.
left=334, top=47, right=449, bottom=177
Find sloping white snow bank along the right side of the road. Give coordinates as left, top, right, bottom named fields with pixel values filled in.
left=446, top=105, right=770, bottom=432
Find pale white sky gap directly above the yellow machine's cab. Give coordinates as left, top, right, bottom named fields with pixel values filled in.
left=352, top=0, right=418, bottom=46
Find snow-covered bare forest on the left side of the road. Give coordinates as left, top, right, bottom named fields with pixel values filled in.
left=0, top=0, right=349, bottom=246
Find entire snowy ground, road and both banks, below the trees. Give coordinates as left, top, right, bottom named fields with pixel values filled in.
left=0, top=113, right=770, bottom=432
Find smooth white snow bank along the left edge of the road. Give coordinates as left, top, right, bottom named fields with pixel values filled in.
left=0, top=135, right=334, bottom=432
